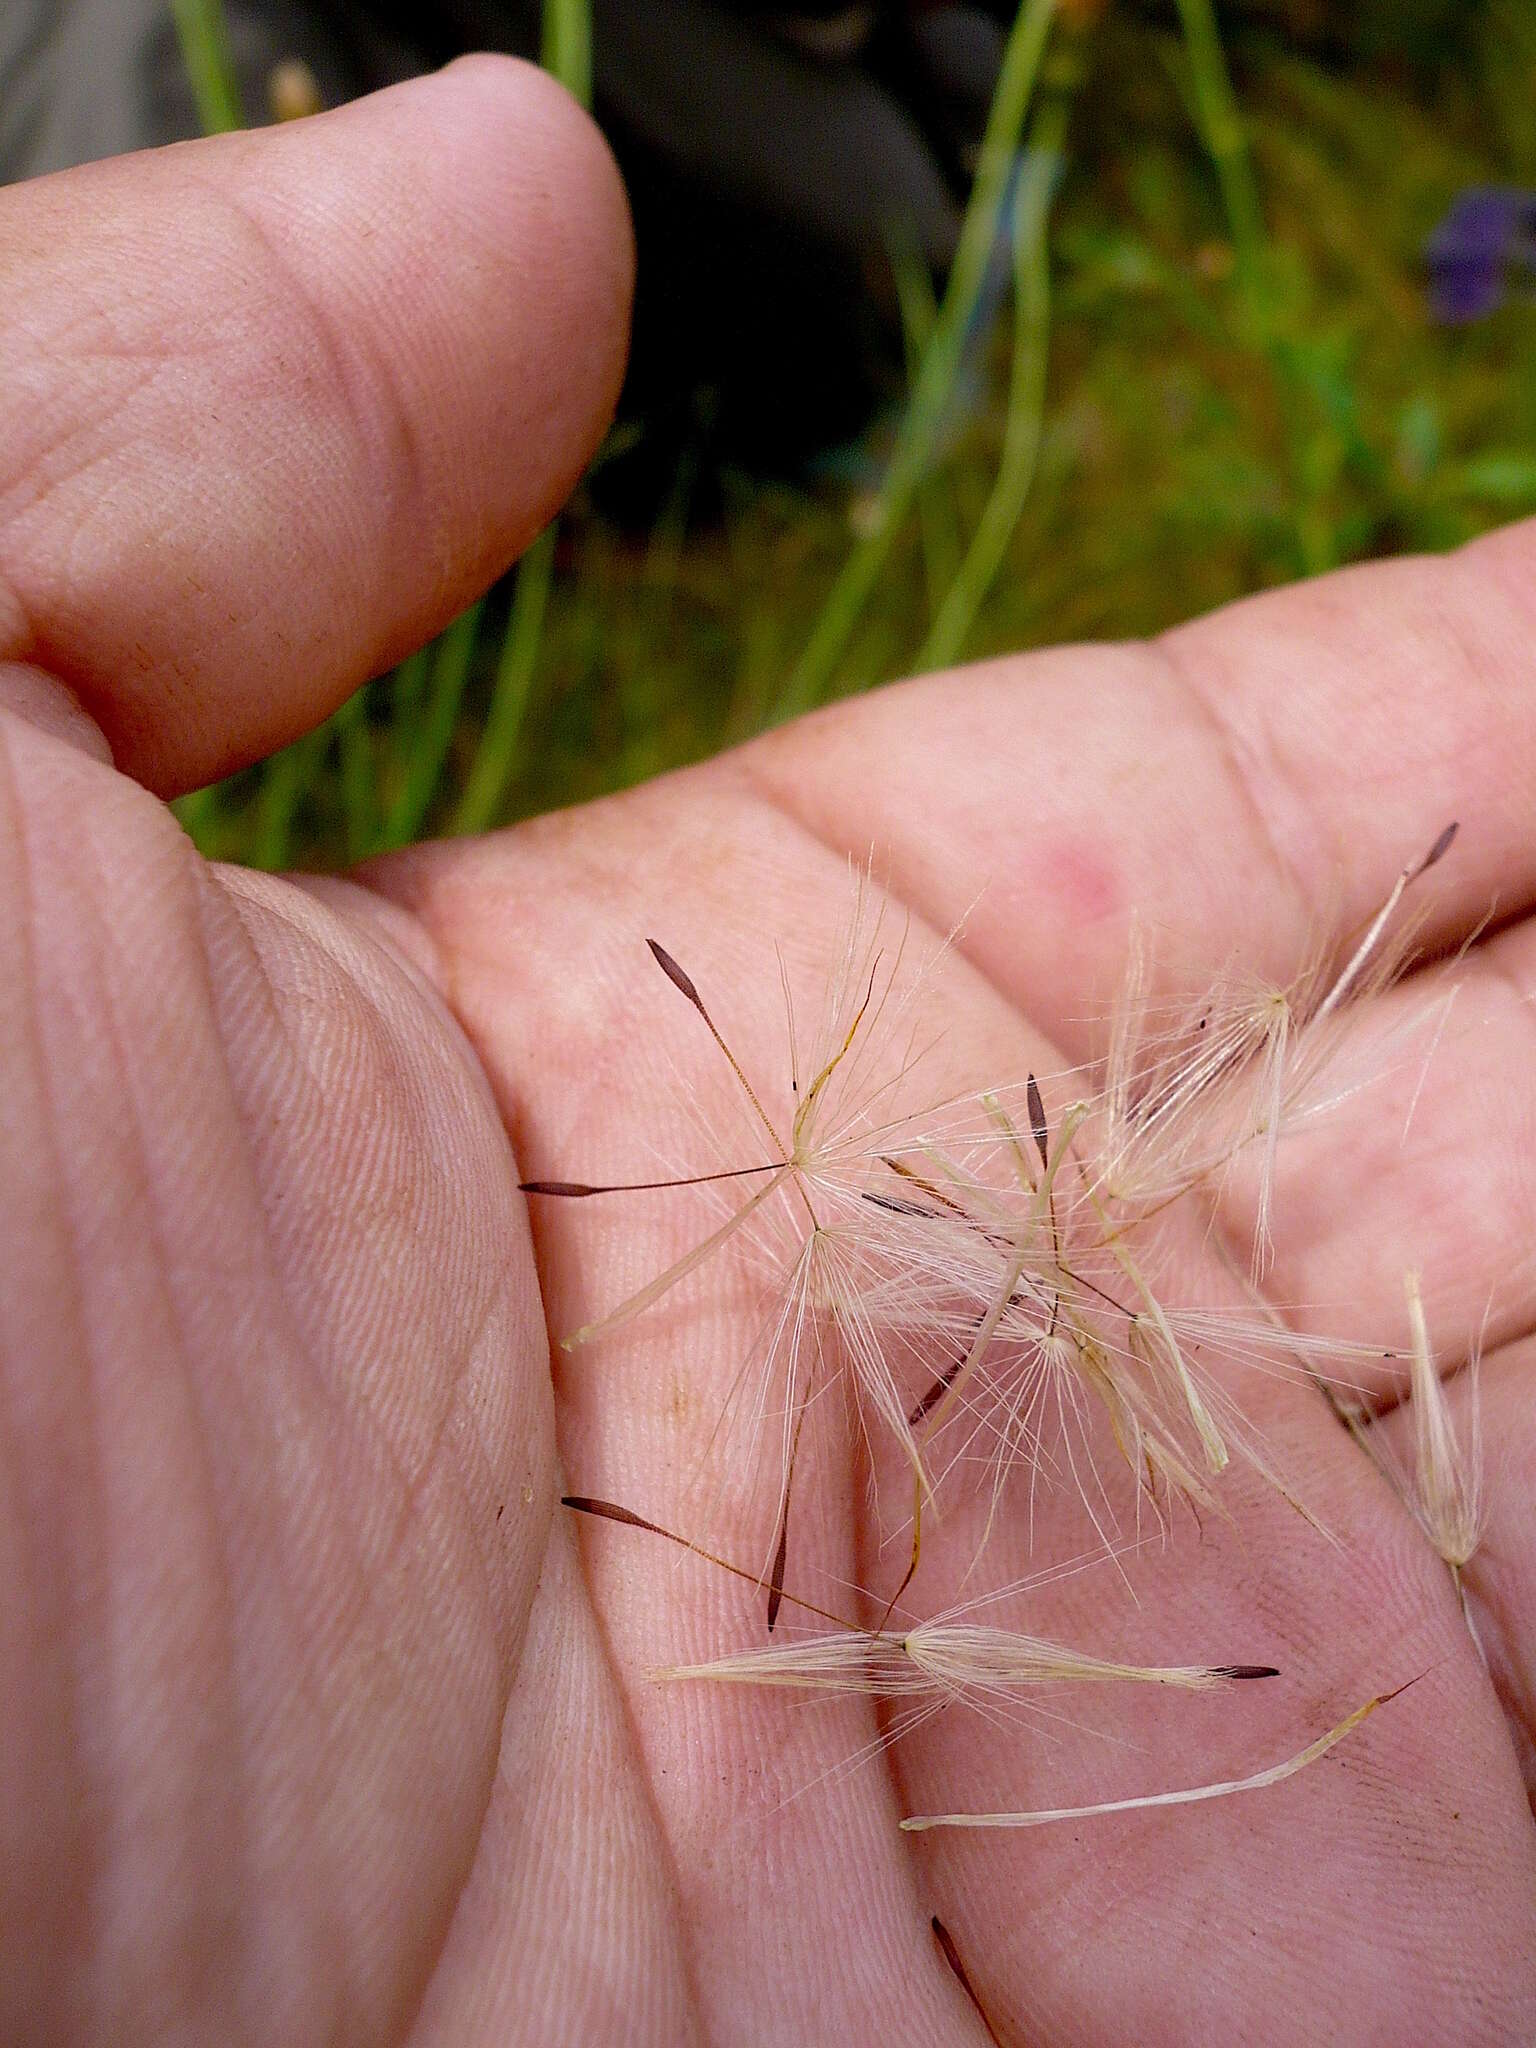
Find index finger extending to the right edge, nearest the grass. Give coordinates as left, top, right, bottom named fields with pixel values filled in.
left=741, top=522, right=1536, bottom=1057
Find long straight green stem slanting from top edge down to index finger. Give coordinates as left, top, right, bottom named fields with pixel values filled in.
left=774, top=0, right=1057, bottom=719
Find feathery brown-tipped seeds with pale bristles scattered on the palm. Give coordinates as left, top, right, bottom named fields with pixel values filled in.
left=524, top=825, right=1479, bottom=1859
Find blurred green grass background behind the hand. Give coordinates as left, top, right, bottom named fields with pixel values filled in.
left=176, top=0, right=1536, bottom=866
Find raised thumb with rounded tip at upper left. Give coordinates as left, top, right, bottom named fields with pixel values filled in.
left=0, top=57, right=631, bottom=793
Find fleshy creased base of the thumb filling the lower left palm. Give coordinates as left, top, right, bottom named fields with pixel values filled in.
left=0, top=719, right=555, bottom=2044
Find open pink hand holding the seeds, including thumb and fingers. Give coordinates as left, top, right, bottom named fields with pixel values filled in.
left=0, top=59, right=1536, bottom=2048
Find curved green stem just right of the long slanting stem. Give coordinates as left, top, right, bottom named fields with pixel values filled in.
left=915, top=102, right=1067, bottom=672
